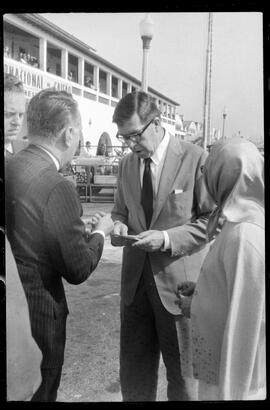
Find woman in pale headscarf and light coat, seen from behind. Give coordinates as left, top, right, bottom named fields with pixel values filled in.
left=177, top=138, right=266, bottom=401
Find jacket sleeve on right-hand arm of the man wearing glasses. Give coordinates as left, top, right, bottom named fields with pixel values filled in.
left=167, top=152, right=215, bottom=256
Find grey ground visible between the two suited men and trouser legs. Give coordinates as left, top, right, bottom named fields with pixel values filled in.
left=57, top=203, right=167, bottom=402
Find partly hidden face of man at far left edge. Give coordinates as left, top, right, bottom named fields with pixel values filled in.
left=4, top=92, right=26, bottom=143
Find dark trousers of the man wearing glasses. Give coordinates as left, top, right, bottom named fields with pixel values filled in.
left=120, top=257, right=189, bottom=401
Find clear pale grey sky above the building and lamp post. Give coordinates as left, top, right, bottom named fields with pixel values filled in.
left=41, top=12, right=264, bottom=138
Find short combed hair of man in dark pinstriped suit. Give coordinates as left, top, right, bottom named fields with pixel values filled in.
left=27, top=88, right=79, bottom=137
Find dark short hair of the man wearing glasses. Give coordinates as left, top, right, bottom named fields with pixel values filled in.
left=113, top=91, right=161, bottom=125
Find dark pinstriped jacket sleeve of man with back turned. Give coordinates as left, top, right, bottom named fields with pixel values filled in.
left=44, top=180, right=104, bottom=284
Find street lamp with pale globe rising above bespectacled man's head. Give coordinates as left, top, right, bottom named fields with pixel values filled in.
left=140, top=13, right=154, bottom=93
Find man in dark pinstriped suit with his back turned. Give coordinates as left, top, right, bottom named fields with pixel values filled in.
left=6, top=89, right=113, bottom=401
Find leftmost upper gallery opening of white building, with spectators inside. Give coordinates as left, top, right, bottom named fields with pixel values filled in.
left=3, top=22, right=39, bottom=68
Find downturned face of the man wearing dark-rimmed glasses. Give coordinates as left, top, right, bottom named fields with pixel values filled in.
left=118, top=113, right=160, bottom=159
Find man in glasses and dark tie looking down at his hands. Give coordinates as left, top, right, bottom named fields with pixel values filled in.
left=112, top=92, right=213, bottom=401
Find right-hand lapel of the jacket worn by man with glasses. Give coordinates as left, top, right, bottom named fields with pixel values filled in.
left=150, top=135, right=182, bottom=229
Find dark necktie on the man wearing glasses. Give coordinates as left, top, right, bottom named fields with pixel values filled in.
left=141, top=158, right=153, bottom=229
